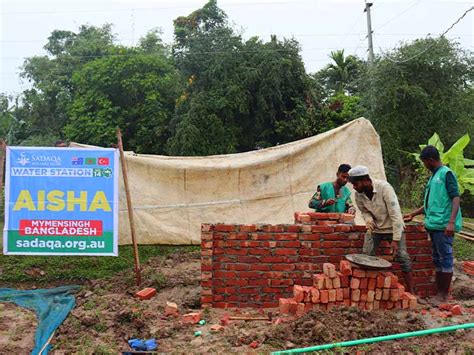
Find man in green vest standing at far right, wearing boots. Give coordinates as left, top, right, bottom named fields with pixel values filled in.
left=404, top=145, right=462, bottom=303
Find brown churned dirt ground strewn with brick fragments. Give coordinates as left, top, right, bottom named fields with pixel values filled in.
left=0, top=253, right=474, bottom=354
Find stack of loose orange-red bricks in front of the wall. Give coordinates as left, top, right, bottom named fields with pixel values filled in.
left=279, top=260, right=417, bottom=316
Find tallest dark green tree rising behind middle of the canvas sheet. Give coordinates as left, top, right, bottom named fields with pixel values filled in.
left=168, top=0, right=313, bottom=155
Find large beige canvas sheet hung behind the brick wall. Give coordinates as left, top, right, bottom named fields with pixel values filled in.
left=71, top=118, right=386, bottom=245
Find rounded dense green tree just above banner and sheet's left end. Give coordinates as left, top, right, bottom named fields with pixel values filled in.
left=64, top=47, right=180, bottom=154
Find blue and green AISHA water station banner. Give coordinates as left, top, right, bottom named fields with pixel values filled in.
left=3, top=147, right=118, bottom=256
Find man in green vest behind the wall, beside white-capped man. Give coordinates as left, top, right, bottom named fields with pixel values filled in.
left=308, top=164, right=355, bottom=214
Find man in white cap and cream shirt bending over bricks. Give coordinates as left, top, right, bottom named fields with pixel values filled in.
left=349, top=165, right=413, bottom=293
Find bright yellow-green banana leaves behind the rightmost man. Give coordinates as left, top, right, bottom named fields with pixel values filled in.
left=409, top=133, right=474, bottom=194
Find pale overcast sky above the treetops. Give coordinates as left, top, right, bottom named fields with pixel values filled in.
left=0, top=0, right=474, bottom=94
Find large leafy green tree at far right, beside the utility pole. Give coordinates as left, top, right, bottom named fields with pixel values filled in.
left=360, top=38, right=474, bottom=171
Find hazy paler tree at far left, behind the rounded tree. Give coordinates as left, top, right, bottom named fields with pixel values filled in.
left=21, top=25, right=114, bottom=135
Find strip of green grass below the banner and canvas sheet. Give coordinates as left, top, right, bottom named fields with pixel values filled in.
left=0, top=245, right=199, bottom=285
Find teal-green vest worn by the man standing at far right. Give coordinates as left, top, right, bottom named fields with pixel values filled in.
left=424, top=166, right=462, bottom=232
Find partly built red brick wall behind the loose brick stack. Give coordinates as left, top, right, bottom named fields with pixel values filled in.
left=201, top=213, right=435, bottom=308
